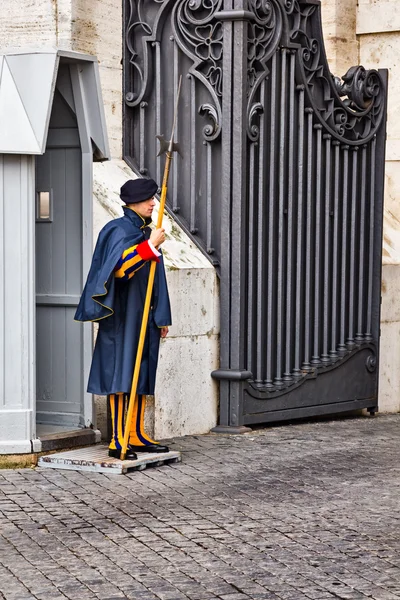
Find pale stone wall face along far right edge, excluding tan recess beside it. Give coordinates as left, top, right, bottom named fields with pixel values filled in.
left=356, top=0, right=400, bottom=412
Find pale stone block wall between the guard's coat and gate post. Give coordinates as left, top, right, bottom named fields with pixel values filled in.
left=154, top=270, right=219, bottom=438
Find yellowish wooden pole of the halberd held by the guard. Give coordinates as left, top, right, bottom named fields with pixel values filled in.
left=121, top=151, right=172, bottom=460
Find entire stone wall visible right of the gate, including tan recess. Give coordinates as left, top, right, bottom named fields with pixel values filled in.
left=322, top=0, right=400, bottom=412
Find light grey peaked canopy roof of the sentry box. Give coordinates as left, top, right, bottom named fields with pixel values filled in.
left=0, top=50, right=110, bottom=160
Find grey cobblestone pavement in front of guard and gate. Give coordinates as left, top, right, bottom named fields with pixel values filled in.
left=0, top=415, right=400, bottom=600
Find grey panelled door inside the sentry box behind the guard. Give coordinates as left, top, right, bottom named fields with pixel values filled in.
left=36, top=90, right=84, bottom=427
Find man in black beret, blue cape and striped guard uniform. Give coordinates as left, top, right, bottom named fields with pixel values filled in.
left=75, top=179, right=171, bottom=460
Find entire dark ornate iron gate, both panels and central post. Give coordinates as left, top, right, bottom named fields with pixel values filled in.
left=124, top=0, right=387, bottom=427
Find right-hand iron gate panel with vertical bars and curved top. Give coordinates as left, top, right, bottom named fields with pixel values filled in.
left=238, top=2, right=386, bottom=424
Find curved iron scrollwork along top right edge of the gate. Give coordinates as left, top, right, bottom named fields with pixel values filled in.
left=284, top=0, right=384, bottom=144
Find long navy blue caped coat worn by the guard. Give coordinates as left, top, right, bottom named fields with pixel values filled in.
left=75, top=207, right=171, bottom=395
